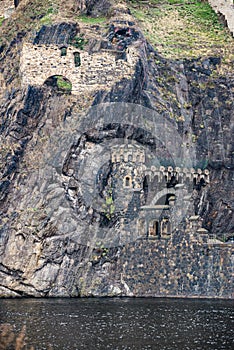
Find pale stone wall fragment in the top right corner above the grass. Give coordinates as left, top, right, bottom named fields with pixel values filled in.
left=208, top=0, right=234, bottom=36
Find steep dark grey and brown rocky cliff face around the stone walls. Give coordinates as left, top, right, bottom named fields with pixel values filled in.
left=0, top=1, right=234, bottom=296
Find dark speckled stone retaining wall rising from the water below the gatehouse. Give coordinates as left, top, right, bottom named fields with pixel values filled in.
left=84, top=229, right=234, bottom=298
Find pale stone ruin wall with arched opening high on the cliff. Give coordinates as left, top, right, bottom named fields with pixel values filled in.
left=20, top=43, right=138, bottom=95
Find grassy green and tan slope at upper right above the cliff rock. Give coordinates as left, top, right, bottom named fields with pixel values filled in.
left=128, top=0, right=234, bottom=66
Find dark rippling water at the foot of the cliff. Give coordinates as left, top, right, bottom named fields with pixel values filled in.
left=0, top=298, right=234, bottom=350
